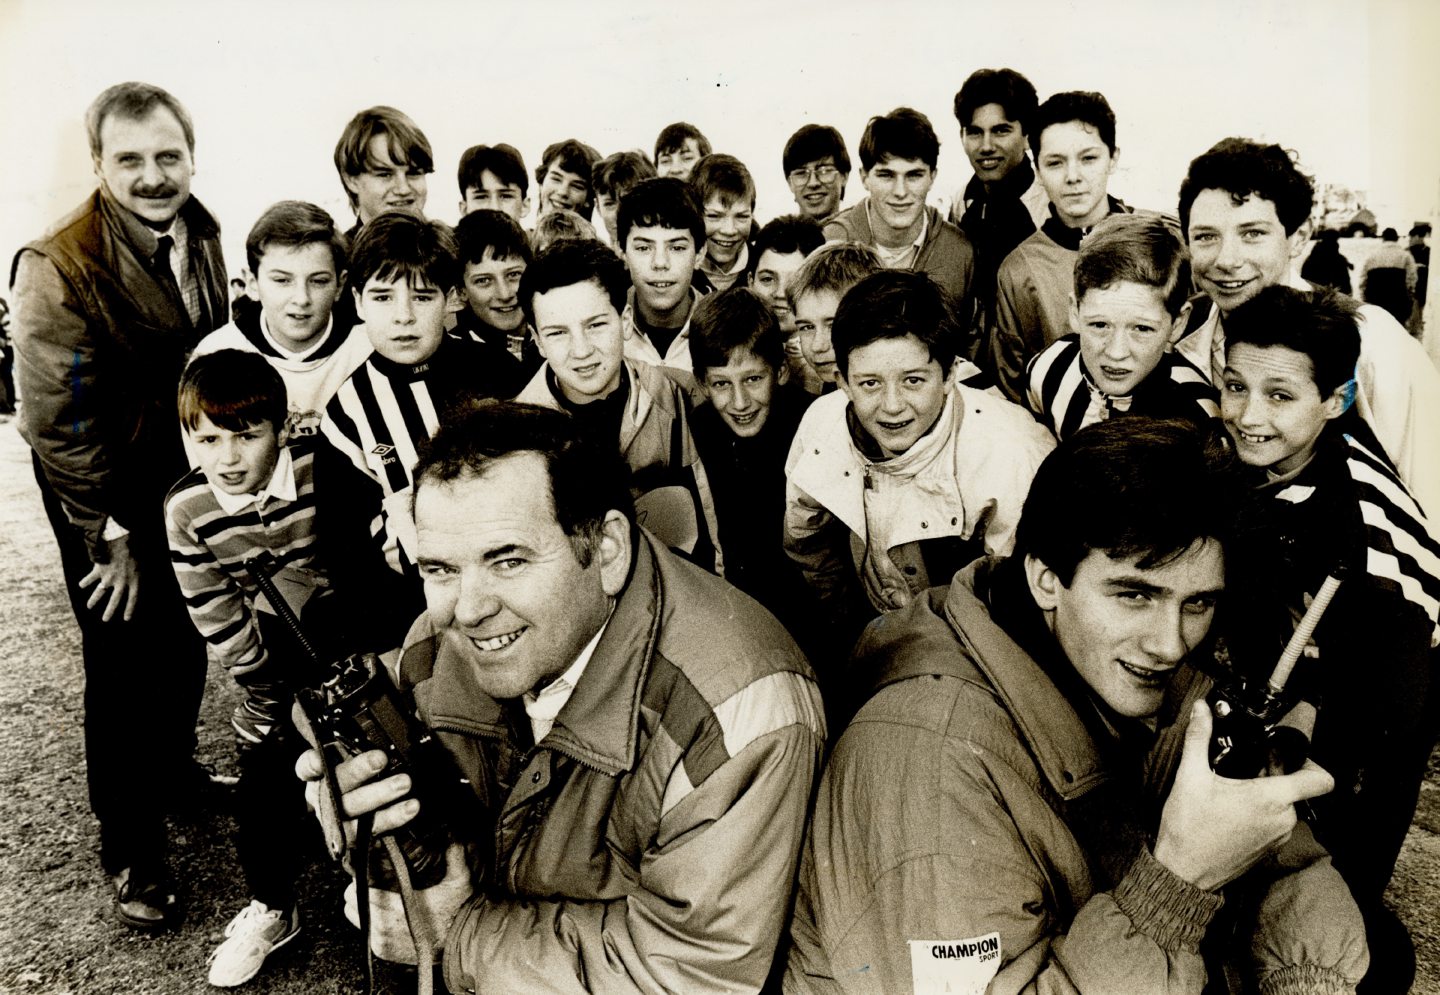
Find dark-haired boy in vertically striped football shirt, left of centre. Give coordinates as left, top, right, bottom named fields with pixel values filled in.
left=321, top=213, right=514, bottom=578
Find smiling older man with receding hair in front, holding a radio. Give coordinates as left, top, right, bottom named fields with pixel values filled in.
left=298, top=400, right=825, bottom=992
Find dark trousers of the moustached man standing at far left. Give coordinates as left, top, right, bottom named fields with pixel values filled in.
left=33, top=459, right=206, bottom=874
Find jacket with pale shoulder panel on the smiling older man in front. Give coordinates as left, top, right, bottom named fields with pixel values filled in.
left=400, top=531, right=825, bottom=992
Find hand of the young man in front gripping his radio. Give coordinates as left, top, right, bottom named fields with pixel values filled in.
left=1155, top=701, right=1335, bottom=891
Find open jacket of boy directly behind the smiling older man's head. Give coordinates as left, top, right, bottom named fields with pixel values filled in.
left=516, top=359, right=724, bottom=576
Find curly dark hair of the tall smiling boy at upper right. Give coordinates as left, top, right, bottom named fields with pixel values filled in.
left=1179, top=138, right=1315, bottom=238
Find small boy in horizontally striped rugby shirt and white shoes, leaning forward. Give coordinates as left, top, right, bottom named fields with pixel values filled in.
left=166, top=348, right=403, bottom=988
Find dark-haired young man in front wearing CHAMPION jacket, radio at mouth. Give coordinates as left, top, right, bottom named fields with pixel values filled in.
left=785, top=416, right=1368, bottom=994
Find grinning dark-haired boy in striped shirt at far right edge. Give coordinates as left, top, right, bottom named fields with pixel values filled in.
left=1220, top=285, right=1440, bottom=992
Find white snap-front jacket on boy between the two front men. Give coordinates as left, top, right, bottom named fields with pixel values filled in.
left=785, top=383, right=1056, bottom=612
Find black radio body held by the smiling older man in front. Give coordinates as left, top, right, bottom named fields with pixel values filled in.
left=295, top=654, right=469, bottom=890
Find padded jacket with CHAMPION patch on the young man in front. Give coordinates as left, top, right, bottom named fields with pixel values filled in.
left=785, top=562, right=1368, bottom=995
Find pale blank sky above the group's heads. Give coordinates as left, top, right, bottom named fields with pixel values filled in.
left=0, top=0, right=1440, bottom=303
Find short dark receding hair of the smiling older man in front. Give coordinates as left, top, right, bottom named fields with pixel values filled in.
left=415, top=400, right=635, bottom=567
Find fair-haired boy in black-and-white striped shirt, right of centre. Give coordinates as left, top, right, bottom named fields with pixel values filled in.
left=1024, top=215, right=1220, bottom=439
